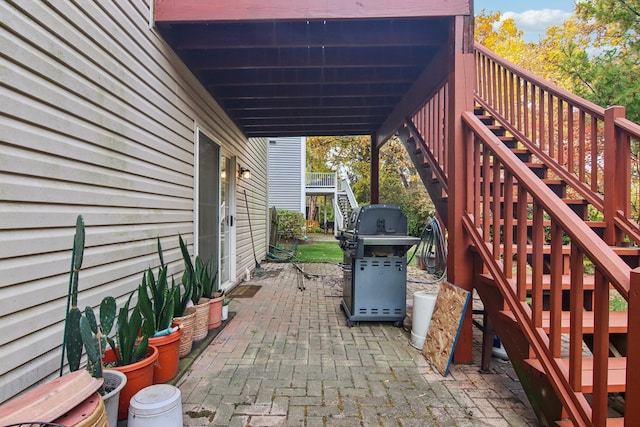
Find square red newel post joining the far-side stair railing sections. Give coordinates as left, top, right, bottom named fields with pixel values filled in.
left=604, top=106, right=631, bottom=246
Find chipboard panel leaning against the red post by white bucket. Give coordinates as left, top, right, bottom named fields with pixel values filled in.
left=422, top=282, right=471, bottom=376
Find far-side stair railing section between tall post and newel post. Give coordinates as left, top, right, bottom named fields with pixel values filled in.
left=476, top=45, right=605, bottom=193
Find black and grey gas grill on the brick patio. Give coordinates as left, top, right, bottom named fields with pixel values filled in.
left=338, top=205, right=420, bottom=326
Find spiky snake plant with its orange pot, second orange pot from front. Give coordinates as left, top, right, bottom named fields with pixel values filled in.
left=138, top=238, right=184, bottom=384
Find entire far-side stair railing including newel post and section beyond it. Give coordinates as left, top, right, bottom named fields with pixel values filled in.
left=475, top=43, right=640, bottom=245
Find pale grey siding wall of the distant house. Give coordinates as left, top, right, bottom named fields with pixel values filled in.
left=268, top=137, right=306, bottom=214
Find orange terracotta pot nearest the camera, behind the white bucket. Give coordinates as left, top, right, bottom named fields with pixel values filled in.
left=104, top=345, right=158, bottom=420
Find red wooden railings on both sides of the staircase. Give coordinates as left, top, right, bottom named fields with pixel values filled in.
left=407, top=44, right=640, bottom=426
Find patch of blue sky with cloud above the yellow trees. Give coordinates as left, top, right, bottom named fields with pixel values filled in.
left=474, top=0, right=575, bottom=42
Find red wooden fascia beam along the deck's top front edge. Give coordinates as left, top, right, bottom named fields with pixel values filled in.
left=154, top=0, right=472, bottom=23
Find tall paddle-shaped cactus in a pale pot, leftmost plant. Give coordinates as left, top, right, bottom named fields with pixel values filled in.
left=60, top=215, right=127, bottom=425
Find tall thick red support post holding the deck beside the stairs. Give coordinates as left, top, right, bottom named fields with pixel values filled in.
left=447, top=16, right=475, bottom=363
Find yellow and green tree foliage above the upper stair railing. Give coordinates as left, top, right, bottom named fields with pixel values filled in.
left=475, top=5, right=640, bottom=122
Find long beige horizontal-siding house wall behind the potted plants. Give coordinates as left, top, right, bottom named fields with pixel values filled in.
left=0, top=0, right=268, bottom=402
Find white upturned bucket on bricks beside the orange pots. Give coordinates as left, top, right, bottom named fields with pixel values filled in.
left=127, top=384, right=182, bottom=427
